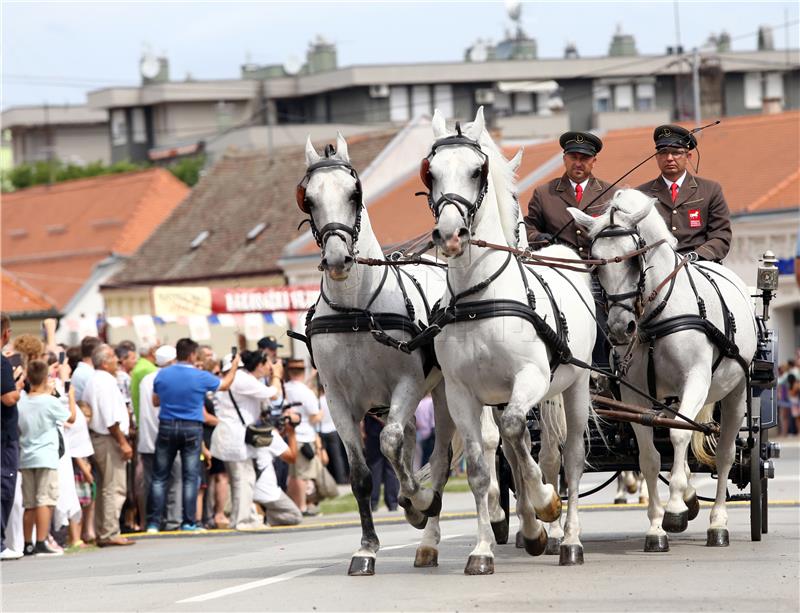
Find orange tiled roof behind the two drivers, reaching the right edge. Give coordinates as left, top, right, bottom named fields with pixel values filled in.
left=352, top=111, right=800, bottom=255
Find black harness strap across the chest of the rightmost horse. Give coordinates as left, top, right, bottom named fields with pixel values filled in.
left=639, top=266, right=749, bottom=397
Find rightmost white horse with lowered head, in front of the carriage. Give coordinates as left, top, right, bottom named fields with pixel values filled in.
left=570, top=189, right=757, bottom=551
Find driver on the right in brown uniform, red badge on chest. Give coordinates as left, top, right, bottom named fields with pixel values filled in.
left=636, top=125, right=731, bottom=262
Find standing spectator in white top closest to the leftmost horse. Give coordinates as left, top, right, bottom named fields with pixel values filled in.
left=283, top=360, right=322, bottom=517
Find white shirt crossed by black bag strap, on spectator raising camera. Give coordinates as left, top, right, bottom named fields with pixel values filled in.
left=210, top=369, right=280, bottom=462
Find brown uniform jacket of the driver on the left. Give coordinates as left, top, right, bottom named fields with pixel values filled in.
left=525, top=174, right=614, bottom=258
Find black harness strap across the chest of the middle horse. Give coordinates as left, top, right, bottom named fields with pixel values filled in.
left=431, top=253, right=572, bottom=378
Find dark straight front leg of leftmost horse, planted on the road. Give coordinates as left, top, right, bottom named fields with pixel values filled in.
left=332, top=412, right=380, bottom=576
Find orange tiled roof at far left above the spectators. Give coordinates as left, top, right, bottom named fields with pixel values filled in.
left=2, top=168, right=189, bottom=309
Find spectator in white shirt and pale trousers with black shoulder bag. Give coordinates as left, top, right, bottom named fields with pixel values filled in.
left=211, top=351, right=283, bottom=531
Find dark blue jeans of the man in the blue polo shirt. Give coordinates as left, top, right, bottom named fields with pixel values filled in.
left=147, top=419, right=203, bottom=526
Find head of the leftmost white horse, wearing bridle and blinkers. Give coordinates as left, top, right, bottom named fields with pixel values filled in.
left=297, top=133, right=363, bottom=281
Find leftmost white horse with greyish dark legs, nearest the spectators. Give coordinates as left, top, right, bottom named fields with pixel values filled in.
left=297, top=134, right=454, bottom=575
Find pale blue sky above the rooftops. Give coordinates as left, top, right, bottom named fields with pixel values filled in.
left=0, top=0, right=800, bottom=109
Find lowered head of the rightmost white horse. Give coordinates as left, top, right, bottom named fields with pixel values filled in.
left=567, top=189, right=657, bottom=344
